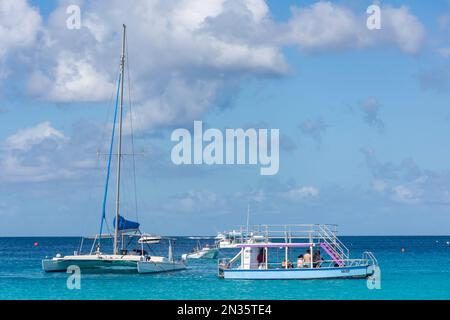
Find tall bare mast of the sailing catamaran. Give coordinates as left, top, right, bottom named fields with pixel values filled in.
left=114, top=25, right=126, bottom=254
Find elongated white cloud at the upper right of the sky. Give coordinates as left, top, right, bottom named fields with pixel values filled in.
left=283, top=1, right=425, bottom=54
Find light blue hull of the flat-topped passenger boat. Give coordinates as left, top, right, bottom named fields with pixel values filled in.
left=219, top=266, right=373, bottom=280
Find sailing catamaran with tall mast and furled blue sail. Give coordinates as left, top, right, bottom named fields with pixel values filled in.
left=42, top=25, right=186, bottom=273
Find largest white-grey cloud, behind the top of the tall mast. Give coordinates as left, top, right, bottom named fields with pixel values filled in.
left=22, top=0, right=288, bottom=130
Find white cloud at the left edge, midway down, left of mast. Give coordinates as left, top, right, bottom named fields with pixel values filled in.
left=0, top=122, right=98, bottom=182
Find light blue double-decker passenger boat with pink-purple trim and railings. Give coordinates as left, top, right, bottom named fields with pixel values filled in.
left=218, top=224, right=378, bottom=280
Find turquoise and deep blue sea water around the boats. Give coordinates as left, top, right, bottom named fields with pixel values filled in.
left=0, top=236, right=450, bottom=300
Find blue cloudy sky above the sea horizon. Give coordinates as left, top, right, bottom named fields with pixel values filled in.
left=0, top=0, right=450, bottom=236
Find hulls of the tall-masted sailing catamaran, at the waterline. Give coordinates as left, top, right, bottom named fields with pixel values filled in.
left=42, top=255, right=186, bottom=273
